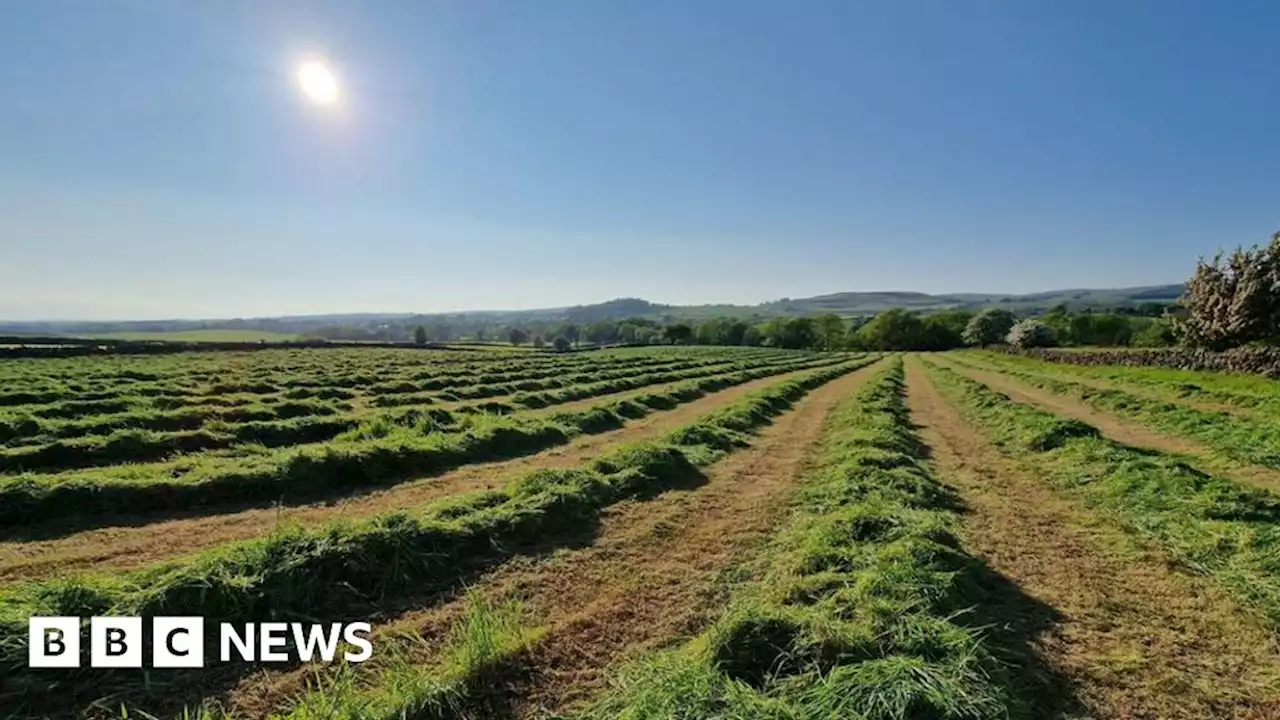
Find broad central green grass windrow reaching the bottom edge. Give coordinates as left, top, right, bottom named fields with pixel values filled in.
left=582, top=361, right=1032, bottom=720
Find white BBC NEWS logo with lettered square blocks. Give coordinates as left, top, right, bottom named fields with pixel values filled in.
left=27, top=618, right=374, bottom=667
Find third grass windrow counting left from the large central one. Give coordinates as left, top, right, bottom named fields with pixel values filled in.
left=0, top=357, right=829, bottom=473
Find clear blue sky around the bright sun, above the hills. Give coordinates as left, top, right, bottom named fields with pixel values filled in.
left=0, top=0, right=1280, bottom=319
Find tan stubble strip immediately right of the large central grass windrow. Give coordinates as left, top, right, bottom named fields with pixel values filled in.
left=908, top=357, right=1280, bottom=720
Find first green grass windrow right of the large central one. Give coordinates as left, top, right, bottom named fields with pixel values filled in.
left=928, top=358, right=1280, bottom=625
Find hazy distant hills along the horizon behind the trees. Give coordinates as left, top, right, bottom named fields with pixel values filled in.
left=0, top=283, right=1183, bottom=336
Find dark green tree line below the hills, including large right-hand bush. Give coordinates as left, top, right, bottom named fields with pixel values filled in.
left=332, top=233, right=1280, bottom=350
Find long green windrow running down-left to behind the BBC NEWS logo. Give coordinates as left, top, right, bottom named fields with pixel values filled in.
left=0, top=359, right=870, bottom=683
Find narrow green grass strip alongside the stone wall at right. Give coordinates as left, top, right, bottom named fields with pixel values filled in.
left=960, top=352, right=1280, bottom=413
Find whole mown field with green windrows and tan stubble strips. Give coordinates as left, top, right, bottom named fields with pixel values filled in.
left=0, top=347, right=1280, bottom=720
